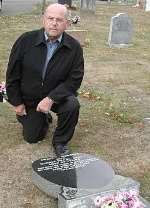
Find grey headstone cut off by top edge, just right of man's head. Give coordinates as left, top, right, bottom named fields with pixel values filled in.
left=80, top=0, right=96, bottom=12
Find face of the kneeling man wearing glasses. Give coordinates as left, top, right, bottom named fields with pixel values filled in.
left=43, top=7, right=69, bottom=40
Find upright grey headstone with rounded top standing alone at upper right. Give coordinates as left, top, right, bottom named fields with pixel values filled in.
left=108, top=13, right=133, bottom=47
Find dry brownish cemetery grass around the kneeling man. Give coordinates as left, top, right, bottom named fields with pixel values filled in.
left=0, top=4, right=150, bottom=208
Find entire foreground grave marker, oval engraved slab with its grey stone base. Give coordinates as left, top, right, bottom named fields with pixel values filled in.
left=32, top=153, right=150, bottom=208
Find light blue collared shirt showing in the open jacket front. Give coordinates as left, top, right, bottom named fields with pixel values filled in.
left=42, top=32, right=62, bottom=80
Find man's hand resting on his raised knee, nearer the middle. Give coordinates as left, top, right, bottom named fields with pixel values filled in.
left=36, top=97, right=54, bottom=113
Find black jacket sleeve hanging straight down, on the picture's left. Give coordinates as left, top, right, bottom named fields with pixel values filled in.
left=6, top=36, right=23, bottom=106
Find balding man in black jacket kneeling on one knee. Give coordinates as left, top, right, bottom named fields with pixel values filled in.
left=6, top=3, right=84, bottom=156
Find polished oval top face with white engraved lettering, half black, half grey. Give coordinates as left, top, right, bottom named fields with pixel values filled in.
left=32, top=153, right=114, bottom=190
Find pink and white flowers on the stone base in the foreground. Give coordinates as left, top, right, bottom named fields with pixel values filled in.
left=94, top=190, right=145, bottom=208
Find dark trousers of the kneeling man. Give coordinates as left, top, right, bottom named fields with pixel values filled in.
left=17, top=96, right=80, bottom=145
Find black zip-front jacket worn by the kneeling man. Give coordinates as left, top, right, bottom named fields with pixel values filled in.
left=6, top=29, right=84, bottom=106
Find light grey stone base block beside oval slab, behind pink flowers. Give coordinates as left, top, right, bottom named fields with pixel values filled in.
left=58, top=175, right=139, bottom=208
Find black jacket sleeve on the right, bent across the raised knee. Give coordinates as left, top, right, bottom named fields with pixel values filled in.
left=48, top=45, right=84, bottom=103
